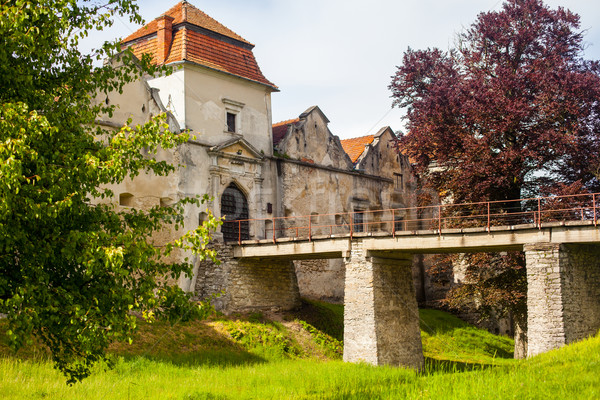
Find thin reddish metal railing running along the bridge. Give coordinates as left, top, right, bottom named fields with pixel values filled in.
left=223, top=193, right=600, bottom=244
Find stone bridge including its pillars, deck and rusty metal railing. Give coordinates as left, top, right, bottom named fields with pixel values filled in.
left=218, top=194, right=600, bottom=368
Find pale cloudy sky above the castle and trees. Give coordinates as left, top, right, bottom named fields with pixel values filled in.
left=85, top=0, right=600, bottom=139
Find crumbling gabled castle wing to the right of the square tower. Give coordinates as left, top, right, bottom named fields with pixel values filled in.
left=273, top=106, right=414, bottom=302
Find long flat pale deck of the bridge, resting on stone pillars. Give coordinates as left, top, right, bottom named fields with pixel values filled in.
left=234, top=221, right=600, bottom=260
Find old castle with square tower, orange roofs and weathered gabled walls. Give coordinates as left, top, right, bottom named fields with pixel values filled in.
left=98, top=1, right=424, bottom=310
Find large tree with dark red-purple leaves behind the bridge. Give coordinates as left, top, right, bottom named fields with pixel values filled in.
left=390, top=0, right=600, bottom=355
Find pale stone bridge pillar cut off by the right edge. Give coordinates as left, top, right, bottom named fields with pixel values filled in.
left=524, top=243, right=600, bottom=357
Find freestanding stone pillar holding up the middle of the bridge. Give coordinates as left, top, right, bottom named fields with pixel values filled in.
left=344, top=241, right=424, bottom=368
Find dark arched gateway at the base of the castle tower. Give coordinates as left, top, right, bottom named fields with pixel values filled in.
left=221, top=183, right=250, bottom=242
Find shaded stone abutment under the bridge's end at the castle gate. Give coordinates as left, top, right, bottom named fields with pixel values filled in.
left=225, top=260, right=300, bottom=312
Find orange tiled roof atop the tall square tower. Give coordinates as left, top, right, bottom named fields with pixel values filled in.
left=123, top=1, right=277, bottom=89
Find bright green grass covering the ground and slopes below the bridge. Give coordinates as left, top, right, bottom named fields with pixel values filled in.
left=0, top=303, right=600, bottom=400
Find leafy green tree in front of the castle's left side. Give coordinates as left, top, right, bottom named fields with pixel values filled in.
left=0, top=0, right=219, bottom=383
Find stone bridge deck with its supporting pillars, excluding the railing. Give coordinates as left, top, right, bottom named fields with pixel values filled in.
left=223, top=221, right=600, bottom=368
